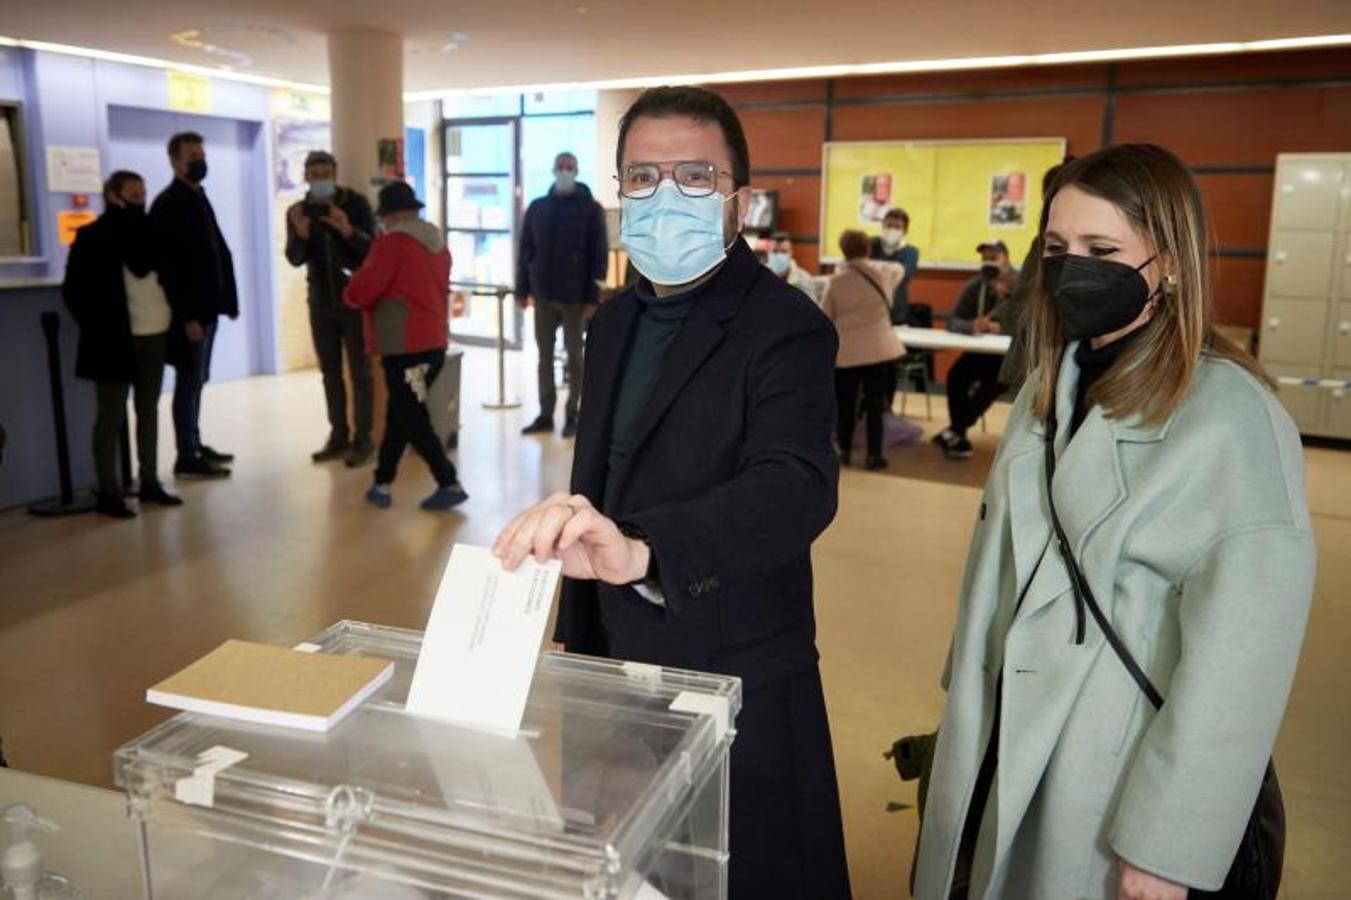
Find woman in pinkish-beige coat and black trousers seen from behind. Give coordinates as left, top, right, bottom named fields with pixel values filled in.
left=821, top=231, right=905, bottom=469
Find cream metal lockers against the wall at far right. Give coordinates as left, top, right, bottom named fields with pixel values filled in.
left=1258, top=153, right=1351, bottom=439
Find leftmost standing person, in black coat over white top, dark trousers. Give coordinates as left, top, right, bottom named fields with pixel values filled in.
left=62, top=169, right=182, bottom=519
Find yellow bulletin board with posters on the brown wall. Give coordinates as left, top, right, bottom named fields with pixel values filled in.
left=820, top=138, right=1065, bottom=269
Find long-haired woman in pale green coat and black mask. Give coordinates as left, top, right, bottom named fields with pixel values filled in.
left=915, top=145, right=1315, bottom=900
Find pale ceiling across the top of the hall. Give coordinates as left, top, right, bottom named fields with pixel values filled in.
left=0, top=0, right=1351, bottom=91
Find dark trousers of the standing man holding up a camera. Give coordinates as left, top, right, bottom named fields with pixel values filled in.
left=309, top=301, right=376, bottom=443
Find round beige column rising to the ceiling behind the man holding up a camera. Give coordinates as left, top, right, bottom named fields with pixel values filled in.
left=328, top=30, right=404, bottom=204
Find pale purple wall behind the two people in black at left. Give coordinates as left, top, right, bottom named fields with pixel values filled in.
left=0, top=47, right=277, bottom=508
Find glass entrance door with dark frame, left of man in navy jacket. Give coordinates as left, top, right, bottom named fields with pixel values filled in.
left=442, top=118, right=521, bottom=350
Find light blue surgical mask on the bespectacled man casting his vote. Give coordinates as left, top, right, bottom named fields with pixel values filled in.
left=619, top=181, right=727, bottom=285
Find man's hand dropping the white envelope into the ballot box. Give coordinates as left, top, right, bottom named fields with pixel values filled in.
left=493, top=493, right=651, bottom=584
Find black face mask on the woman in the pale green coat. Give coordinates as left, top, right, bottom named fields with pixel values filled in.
left=1042, top=253, right=1154, bottom=341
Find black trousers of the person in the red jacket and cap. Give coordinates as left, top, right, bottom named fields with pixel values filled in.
left=376, top=350, right=459, bottom=488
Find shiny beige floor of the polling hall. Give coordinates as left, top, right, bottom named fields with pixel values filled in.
left=0, top=351, right=1351, bottom=899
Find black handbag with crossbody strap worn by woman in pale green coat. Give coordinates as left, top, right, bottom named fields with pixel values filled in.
left=1046, top=411, right=1285, bottom=900
